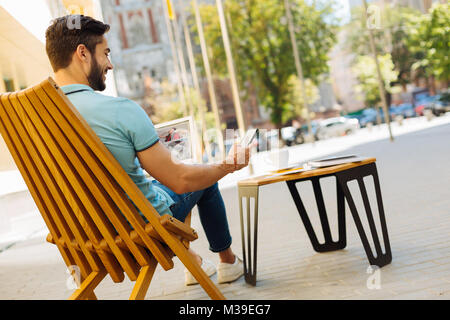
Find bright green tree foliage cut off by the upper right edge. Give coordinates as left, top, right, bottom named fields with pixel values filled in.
left=408, top=3, right=450, bottom=89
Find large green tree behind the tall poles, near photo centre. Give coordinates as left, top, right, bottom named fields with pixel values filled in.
left=190, top=0, right=337, bottom=127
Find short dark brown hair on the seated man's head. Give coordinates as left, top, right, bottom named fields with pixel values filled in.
left=45, top=15, right=109, bottom=72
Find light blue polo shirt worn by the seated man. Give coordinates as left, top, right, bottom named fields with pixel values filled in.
left=61, top=84, right=174, bottom=215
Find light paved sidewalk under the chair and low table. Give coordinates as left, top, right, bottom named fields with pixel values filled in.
left=0, top=115, right=450, bottom=299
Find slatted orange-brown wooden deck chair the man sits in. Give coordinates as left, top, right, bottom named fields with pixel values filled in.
left=0, top=78, right=225, bottom=299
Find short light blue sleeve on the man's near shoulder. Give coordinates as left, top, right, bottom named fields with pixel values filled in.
left=116, top=99, right=159, bottom=152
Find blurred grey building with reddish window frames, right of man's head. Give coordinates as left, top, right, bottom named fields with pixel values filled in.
left=100, top=0, right=174, bottom=104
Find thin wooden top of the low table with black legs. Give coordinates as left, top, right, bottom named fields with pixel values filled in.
left=238, top=158, right=376, bottom=187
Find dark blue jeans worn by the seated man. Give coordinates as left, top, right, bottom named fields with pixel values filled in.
left=152, top=180, right=231, bottom=252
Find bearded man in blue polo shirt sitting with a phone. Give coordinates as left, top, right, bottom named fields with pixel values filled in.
left=46, top=15, right=256, bottom=285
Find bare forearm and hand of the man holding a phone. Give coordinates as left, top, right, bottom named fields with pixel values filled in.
left=137, top=142, right=249, bottom=194
